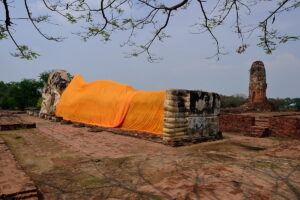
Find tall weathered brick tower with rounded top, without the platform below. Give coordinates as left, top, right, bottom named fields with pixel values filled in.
left=242, top=61, right=275, bottom=112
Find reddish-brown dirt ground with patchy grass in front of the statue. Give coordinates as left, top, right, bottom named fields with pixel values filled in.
left=0, top=115, right=300, bottom=200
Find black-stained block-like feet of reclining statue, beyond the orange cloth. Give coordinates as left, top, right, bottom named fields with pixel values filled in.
left=163, top=89, right=221, bottom=141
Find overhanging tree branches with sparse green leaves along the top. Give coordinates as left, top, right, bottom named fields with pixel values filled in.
left=0, top=0, right=300, bottom=61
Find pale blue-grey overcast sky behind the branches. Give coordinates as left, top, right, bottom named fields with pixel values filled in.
left=0, top=1, right=300, bottom=98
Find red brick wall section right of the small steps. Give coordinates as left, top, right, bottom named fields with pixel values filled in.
left=269, top=117, right=300, bottom=138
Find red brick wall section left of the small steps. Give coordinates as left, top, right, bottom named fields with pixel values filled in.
left=219, top=114, right=255, bottom=132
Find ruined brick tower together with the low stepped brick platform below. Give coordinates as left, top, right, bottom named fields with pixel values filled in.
left=220, top=61, right=300, bottom=138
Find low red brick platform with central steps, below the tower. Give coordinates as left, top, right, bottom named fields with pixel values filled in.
left=220, top=112, right=300, bottom=138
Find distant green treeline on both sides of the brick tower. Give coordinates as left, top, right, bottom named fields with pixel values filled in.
left=221, top=94, right=300, bottom=110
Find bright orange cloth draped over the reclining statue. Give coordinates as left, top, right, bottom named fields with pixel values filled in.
left=55, top=75, right=165, bottom=134
